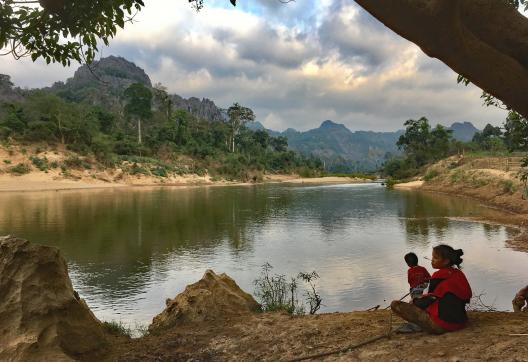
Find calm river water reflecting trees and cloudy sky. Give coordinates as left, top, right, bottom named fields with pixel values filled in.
left=0, top=184, right=528, bottom=326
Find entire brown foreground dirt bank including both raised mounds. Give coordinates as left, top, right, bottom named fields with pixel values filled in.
left=0, top=238, right=528, bottom=362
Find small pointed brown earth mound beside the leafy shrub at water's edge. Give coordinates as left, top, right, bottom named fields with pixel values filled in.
left=149, top=270, right=260, bottom=331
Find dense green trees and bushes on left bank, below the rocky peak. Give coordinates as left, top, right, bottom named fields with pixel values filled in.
left=0, top=83, right=323, bottom=181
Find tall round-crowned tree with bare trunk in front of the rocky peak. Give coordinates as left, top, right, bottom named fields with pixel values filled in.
left=125, top=83, right=152, bottom=144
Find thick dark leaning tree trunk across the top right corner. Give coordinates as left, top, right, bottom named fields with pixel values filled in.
left=356, top=0, right=528, bottom=117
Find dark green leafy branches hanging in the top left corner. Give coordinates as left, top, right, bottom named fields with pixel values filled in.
left=0, top=0, right=144, bottom=65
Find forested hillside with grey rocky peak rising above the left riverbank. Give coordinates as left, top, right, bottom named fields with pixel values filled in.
left=0, top=57, right=322, bottom=180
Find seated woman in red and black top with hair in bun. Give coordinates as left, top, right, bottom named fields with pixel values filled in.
left=391, top=245, right=472, bottom=334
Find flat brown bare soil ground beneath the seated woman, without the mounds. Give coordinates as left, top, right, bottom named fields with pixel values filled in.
left=103, top=311, right=528, bottom=361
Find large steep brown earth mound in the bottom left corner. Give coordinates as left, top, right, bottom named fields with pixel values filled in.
left=0, top=237, right=106, bottom=361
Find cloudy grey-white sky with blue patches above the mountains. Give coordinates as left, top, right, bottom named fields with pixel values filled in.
left=0, top=0, right=506, bottom=131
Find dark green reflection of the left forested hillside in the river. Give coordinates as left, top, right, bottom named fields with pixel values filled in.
left=0, top=187, right=291, bottom=293
